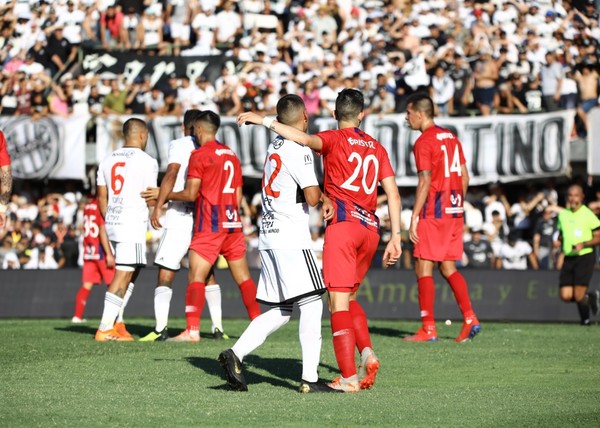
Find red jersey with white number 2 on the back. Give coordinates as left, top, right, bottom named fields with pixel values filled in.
left=188, top=141, right=242, bottom=232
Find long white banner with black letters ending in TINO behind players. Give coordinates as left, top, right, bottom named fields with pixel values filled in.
left=97, top=110, right=575, bottom=186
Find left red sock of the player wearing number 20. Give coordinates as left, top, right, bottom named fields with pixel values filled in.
left=331, top=311, right=356, bottom=379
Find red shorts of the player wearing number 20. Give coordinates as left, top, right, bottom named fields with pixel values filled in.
left=323, top=221, right=379, bottom=293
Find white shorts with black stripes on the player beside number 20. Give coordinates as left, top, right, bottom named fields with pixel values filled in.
left=256, top=249, right=325, bottom=305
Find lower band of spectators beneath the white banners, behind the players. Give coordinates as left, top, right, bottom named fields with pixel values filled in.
left=0, top=183, right=600, bottom=270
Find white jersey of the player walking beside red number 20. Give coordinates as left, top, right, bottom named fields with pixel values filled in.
left=259, top=137, right=319, bottom=249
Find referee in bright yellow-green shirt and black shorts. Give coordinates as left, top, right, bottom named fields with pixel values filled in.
left=554, top=184, right=600, bottom=325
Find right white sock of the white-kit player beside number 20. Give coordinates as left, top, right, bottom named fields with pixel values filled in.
left=298, top=296, right=323, bottom=382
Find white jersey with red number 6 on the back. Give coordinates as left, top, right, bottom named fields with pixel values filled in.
left=98, top=147, right=158, bottom=242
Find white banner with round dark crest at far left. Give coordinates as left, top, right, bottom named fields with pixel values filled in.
left=0, top=116, right=89, bottom=180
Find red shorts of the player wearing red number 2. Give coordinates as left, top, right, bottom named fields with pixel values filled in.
left=190, top=229, right=246, bottom=264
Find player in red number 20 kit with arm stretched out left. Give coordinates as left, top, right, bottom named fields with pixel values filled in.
left=237, top=89, right=402, bottom=392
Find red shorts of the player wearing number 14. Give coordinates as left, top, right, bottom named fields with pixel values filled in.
left=413, top=218, right=464, bottom=262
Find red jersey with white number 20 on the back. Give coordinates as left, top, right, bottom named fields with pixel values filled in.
left=318, top=128, right=394, bottom=229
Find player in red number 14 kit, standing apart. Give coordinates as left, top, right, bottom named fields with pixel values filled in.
left=404, top=93, right=481, bottom=342
